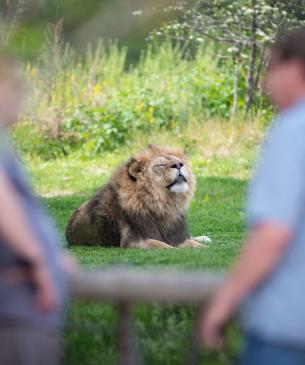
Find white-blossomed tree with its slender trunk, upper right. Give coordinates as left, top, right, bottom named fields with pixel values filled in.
left=150, top=0, right=305, bottom=117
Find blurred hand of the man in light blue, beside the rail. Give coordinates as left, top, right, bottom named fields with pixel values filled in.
left=200, top=296, right=235, bottom=350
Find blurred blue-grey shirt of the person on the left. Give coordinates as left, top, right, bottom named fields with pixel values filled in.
left=0, top=134, right=67, bottom=332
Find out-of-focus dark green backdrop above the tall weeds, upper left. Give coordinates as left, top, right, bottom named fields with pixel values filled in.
left=0, top=0, right=169, bottom=62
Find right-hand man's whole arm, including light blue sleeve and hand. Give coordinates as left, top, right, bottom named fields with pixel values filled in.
left=202, top=117, right=305, bottom=348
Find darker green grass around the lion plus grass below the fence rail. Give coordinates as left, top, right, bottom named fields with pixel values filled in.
left=40, top=177, right=245, bottom=365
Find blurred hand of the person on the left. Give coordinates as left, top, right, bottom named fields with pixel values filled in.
left=31, top=264, right=58, bottom=312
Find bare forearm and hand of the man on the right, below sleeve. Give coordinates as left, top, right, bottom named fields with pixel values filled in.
left=202, top=222, right=292, bottom=348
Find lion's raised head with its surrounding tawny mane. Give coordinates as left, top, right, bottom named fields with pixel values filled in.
left=115, top=145, right=195, bottom=214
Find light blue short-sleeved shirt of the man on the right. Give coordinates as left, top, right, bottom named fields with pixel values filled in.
left=241, top=100, right=305, bottom=347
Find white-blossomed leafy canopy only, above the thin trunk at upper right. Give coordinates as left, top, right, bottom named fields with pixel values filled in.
left=150, top=0, right=305, bottom=49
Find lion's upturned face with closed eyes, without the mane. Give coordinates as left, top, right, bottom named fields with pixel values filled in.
left=129, top=146, right=194, bottom=194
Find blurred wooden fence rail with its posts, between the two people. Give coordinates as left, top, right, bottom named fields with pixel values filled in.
left=70, top=268, right=224, bottom=365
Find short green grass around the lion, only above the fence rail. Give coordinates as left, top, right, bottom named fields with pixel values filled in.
left=44, top=177, right=245, bottom=269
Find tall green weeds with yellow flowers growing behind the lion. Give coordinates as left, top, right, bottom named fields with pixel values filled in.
left=15, top=41, right=262, bottom=159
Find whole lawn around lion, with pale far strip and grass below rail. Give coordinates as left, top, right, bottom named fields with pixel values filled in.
left=26, top=121, right=261, bottom=365
